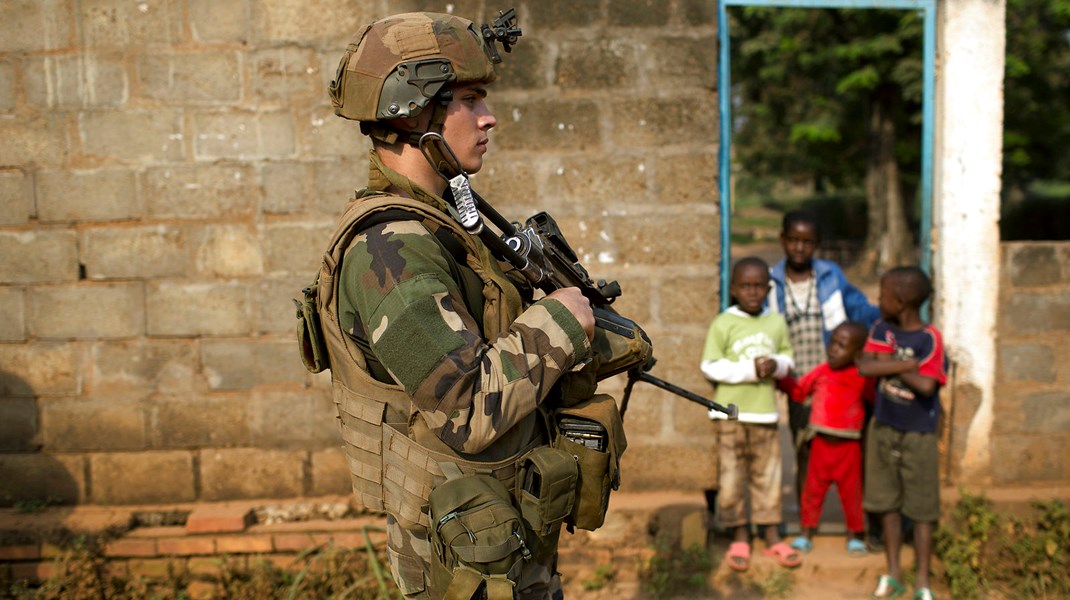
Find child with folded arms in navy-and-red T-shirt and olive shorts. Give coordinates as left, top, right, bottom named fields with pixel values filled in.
left=858, top=266, right=947, bottom=600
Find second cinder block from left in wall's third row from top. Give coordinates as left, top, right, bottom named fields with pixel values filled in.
left=78, top=108, right=185, bottom=163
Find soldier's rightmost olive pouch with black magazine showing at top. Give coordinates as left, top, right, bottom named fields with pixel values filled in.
left=554, top=394, right=628, bottom=530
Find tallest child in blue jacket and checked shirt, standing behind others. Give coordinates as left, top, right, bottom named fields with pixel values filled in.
left=769, top=211, right=881, bottom=543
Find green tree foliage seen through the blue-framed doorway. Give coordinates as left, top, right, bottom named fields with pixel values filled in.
left=730, top=7, right=921, bottom=201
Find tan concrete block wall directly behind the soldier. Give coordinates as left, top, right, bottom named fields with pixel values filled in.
left=0, top=0, right=720, bottom=505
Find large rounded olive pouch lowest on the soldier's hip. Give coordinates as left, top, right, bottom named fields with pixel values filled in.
left=428, top=463, right=533, bottom=600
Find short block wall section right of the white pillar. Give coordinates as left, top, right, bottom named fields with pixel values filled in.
left=991, top=242, right=1070, bottom=486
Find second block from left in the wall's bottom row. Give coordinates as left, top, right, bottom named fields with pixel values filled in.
left=89, top=451, right=196, bottom=502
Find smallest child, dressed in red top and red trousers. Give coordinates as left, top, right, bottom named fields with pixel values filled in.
left=779, top=321, right=873, bottom=556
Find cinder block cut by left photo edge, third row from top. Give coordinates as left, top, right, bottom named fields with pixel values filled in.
left=0, top=114, right=71, bottom=167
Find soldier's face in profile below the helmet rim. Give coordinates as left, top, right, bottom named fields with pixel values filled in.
left=442, top=82, right=498, bottom=173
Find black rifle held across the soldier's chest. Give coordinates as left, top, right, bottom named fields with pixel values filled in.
left=419, top=132, right=739, bottom=419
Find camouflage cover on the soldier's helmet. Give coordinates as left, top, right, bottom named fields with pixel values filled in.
left=328, top=13, right=495, bottom=121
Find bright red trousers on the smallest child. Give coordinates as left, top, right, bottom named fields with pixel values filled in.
left=799, top=434, right=866, bottom=533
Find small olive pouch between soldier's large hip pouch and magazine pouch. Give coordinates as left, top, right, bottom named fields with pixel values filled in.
left=516, top=446, right=580, bottom=536
